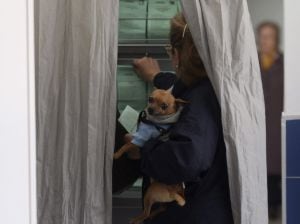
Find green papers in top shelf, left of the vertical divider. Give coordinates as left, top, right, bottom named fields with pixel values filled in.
left=119, top=0, right=148, bottom=42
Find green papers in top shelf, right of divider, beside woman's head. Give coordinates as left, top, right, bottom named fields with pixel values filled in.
left=148, top=0, right=179, bottom=39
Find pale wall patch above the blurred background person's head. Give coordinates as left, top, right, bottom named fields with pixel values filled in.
left=248, top=0, right=284, bottom=48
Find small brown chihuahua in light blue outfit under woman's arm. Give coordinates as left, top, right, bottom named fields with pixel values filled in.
left=114, top=89, right=187, bottom=224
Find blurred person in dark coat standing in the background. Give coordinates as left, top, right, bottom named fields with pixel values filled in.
left=257, top=22, right=284, bottom=218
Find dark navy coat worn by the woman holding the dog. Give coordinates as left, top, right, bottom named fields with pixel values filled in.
left=141, top=73, right=233, bottom=224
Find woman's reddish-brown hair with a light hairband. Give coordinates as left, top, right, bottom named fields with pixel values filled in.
left=170, top=13, right=207, bottom=84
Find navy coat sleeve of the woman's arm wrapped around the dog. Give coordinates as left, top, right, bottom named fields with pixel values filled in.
left=141, top=85, right=221, bottom=184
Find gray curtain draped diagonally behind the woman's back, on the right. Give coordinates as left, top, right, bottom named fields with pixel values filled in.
left=181, top=0, right=268, bottom=224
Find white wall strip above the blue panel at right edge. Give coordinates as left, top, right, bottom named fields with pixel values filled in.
left=284, top=0, right=300, bottom=115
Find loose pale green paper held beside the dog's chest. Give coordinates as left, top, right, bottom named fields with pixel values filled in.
left=118, top=105, right=139, bottom=134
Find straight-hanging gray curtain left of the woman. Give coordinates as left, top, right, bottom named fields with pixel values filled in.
left=35, top=0, right=119, bottom=224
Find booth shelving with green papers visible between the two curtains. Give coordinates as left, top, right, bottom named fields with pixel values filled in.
left=113, top=0, right=180, bottom=224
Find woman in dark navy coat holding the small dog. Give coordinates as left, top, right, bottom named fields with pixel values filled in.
left=134, top=15, right=233, bottom=224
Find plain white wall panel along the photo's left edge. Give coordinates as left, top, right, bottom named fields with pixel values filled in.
left=0, top=0, right=36, bottom=224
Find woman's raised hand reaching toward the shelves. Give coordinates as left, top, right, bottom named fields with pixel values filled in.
left=133, top=57, right=160, bottom=82
